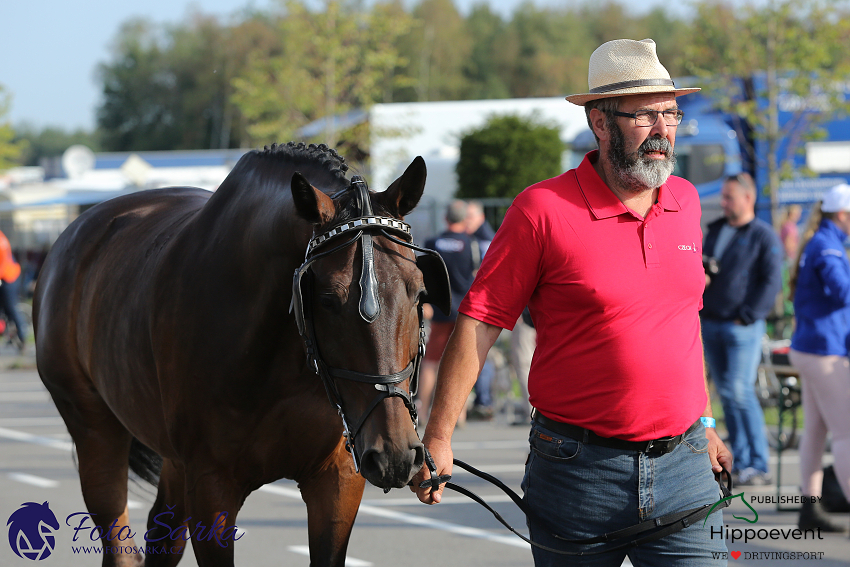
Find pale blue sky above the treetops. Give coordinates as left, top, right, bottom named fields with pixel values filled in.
left=0, top=0, right=681, bottom=130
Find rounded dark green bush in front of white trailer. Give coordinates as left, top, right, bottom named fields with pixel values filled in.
left=457, top=115, right=564, bottom=199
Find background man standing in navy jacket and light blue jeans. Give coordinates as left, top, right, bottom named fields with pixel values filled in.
left=700, top=173, right=784, bottom=486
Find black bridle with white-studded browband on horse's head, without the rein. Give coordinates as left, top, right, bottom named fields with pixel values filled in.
left=290, top=176, right=445, bottom=472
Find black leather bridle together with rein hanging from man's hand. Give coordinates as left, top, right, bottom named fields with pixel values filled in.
left=290, top=181, right=732, bottom=556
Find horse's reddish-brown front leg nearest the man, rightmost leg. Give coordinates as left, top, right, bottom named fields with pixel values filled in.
left=299, top=443, right=366, bottom=567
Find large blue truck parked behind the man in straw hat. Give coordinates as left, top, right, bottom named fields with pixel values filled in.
left=573, top=73, right=850, bottom=225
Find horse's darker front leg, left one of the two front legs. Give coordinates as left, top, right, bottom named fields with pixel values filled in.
left=181, top=470, right=247, bottom=567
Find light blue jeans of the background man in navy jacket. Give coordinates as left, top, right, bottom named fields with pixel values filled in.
left=702, top=319, right=770, bottom=472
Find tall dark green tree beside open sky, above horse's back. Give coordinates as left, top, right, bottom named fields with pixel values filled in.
left=97, top=13, right=278, bottom=151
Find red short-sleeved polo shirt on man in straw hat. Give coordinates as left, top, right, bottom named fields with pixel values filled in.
left=459, top=151, right=706, bottom=441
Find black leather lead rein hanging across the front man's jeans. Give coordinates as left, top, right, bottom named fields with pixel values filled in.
left=410, top=449, right=732, bottom=556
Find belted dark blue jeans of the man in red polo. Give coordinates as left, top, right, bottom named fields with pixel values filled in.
left=522, top=423, right=726, bottom=567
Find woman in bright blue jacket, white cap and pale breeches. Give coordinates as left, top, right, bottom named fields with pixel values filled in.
left=790, top=184, right=850, bottom=532
